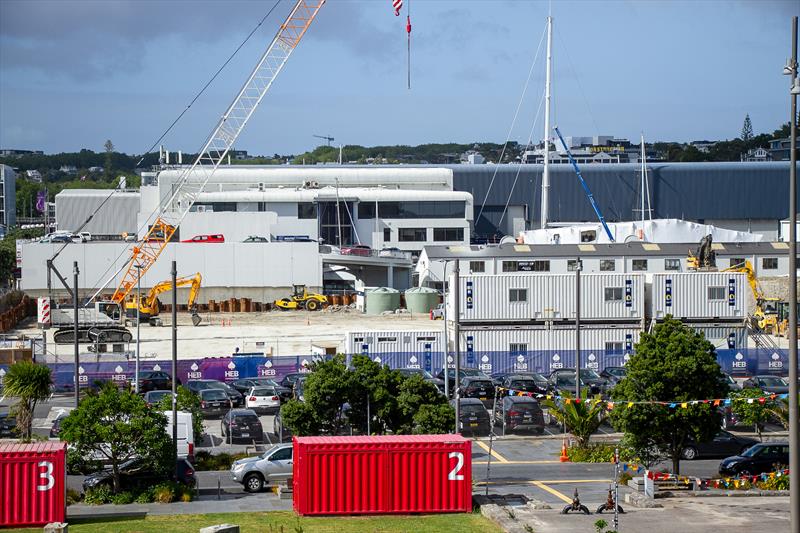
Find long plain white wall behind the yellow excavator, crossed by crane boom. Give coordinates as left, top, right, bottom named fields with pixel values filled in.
left=21, top=242, right=322, bottom=303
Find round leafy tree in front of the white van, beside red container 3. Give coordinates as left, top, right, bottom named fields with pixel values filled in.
left=60, top=383, right=174, bottom=492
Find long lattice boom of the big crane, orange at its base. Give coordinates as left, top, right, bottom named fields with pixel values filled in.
left=104, top=0, right=326, bottom=306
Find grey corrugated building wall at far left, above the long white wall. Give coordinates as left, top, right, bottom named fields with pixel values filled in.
left=55, top=190, right=139, bottom=235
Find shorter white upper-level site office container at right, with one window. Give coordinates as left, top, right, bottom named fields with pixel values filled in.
left=650, top=272, right=750, bottom=321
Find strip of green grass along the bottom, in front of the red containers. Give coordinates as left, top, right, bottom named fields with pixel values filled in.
left=4, top=511, right=502, bottom=533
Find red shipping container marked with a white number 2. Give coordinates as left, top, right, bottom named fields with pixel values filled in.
left=293, top=435, right=472, bottom=515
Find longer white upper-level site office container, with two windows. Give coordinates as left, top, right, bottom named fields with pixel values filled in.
left=448, top=273, right=645, bottom=323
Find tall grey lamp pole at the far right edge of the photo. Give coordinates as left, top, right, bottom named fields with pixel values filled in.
left=784, top=17, right=800, bottom=533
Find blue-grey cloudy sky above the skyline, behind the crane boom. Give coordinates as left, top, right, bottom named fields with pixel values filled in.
left=0, top=0, right=800, bottom=154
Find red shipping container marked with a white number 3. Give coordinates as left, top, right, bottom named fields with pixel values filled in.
left=0, top=442, right=67, bottom=527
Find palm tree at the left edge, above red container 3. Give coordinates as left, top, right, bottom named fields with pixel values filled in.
left=3, top=361, right=52, bottom=441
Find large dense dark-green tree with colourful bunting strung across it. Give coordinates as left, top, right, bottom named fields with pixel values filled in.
left=611, top=316, right=728, bottom=474
